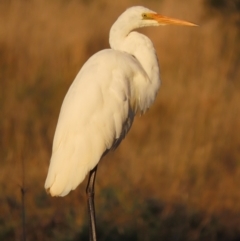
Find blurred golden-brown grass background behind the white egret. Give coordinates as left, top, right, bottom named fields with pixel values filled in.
left=0, top=0, right=240, bottom=241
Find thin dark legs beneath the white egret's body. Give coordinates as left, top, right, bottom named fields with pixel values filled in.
left=86, top=166, right=97, bottom=241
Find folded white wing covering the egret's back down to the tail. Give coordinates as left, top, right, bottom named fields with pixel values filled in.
left=45, top=50, right=146, bottom=196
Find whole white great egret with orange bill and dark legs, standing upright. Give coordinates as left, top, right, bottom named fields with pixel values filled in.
left=45, top=6, right=195, bottom=240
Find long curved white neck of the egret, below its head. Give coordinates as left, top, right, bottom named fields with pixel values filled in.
left=109, top=22, right=160, bottom=104
